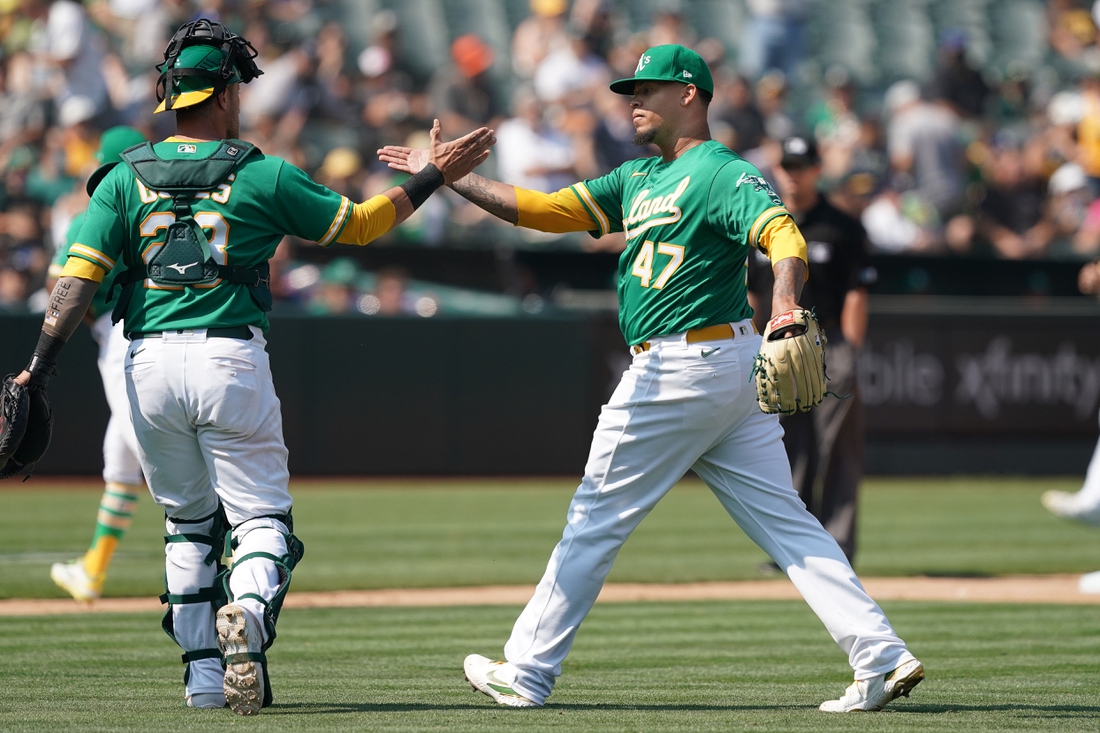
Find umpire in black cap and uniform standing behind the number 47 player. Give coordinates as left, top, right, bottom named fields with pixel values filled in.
left=748, top=138, right=878, bottom=561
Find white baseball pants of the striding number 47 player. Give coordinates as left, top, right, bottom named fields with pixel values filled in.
left=505, top=320, right=913, bottom=702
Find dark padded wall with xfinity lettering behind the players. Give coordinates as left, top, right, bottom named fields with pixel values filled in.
left=0, top=297, right=1100, bottom=474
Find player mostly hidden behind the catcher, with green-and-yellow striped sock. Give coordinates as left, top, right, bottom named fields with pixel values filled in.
left=47, top=125, right=145, bottom=602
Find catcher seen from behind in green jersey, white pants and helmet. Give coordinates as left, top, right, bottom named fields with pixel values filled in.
left=15, top=19, right=494, bottom=714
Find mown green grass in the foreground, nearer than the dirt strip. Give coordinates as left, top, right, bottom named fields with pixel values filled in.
left=0, top=602, right=1100, bottom=732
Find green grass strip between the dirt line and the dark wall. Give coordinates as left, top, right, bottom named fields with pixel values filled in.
left=0, top=478, right=1100, bottom=598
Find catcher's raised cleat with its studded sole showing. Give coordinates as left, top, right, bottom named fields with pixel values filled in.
left=215, top=603, right=264, bottom=715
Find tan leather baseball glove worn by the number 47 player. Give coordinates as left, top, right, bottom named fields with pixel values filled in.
left=752, top=310, right=826, bottom=415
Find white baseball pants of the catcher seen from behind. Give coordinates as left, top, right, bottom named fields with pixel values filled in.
left=125, top=328, right=293, bottom=694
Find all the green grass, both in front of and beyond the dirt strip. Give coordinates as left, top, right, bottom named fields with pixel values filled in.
left=0, top=479, right=1100, bottom=731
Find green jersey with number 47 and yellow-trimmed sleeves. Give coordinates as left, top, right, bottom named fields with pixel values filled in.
left=571, top=140, right=789, bottom=344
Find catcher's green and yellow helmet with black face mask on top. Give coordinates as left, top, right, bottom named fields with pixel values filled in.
left=156, top=18, right=263, bottom=112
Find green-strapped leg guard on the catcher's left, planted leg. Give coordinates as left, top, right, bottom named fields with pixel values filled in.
left=161, top=506, right=228, bottom=696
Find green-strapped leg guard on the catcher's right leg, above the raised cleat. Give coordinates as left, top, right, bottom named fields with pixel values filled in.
left=222, top=514, right=305, bottom=708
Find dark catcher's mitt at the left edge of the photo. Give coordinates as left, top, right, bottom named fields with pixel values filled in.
left=0, top=374, right=54, bottom=479
